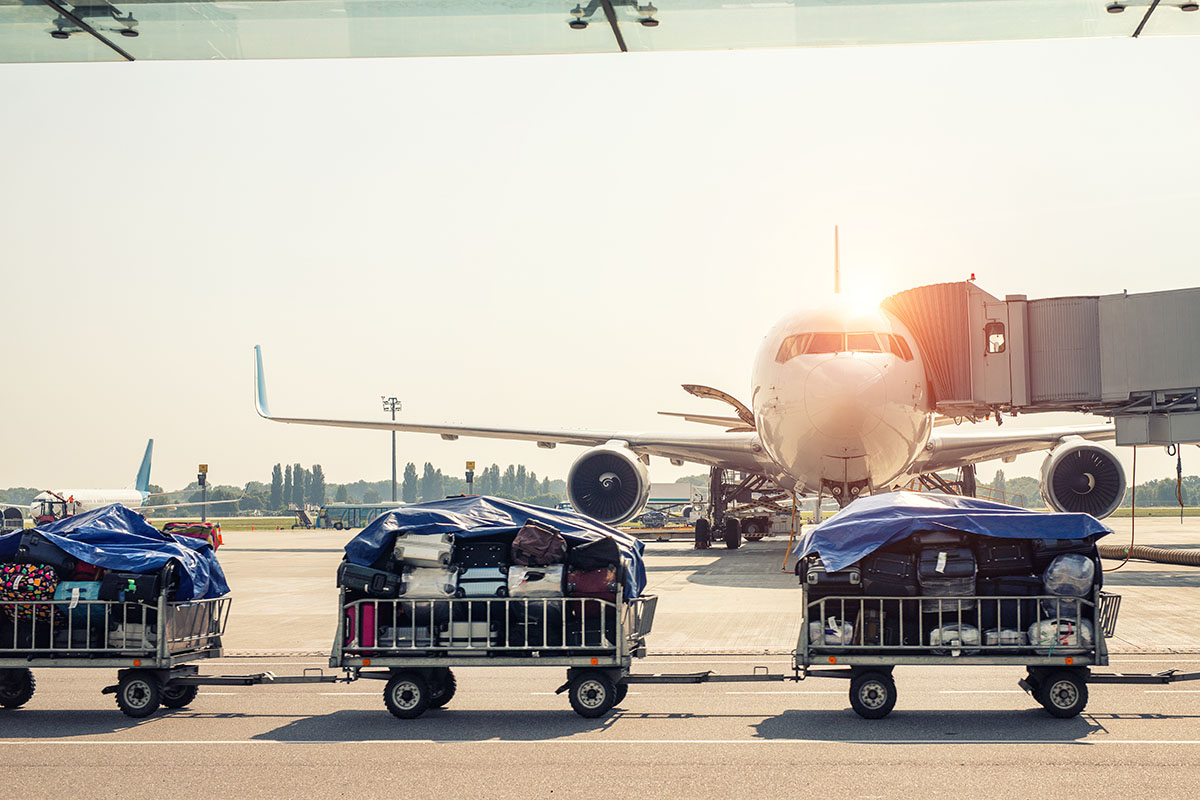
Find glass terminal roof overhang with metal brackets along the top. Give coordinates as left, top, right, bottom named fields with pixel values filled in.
left=0, top=0, right=1200, bottom=62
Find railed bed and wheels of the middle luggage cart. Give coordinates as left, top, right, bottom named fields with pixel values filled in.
left=329, top=590, right=658, bottom=720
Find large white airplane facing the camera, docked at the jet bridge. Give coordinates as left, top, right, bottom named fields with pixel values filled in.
left=246, top=283, right=1126, bottom=548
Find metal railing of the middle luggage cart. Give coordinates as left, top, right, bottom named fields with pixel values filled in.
left=330, top=591, right=658, bottom=668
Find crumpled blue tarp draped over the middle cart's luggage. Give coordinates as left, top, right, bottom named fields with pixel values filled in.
left=346, top=497, right=646, bottom=600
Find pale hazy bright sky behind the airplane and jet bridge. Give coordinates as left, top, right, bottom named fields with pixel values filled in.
left=0, top=37, right=1200, bottom=488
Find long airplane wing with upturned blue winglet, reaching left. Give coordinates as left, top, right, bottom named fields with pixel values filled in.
left=254, top=344, right=773, bottom=474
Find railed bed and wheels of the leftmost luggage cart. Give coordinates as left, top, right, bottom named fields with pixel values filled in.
left=0, top=594, right=232, bottom=717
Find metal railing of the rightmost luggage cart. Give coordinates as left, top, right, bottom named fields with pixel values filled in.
left=796, top=588, right=1121, bottom=669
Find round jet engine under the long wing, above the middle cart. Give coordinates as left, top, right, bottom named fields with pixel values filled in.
left=566, top=443, right=650, bottom=525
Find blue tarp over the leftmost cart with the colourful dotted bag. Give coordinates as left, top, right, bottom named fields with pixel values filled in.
left=0, top=504, right=229, bottom=600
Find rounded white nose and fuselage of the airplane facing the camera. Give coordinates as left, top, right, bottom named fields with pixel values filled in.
left=751, top=301, right=932, bottom=500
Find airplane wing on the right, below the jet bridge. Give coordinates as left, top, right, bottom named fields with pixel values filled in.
left=912, top=425, right=1116, bottom=475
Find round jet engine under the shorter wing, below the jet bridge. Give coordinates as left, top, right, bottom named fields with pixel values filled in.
left=1042, top=440, right=1126, bottom=518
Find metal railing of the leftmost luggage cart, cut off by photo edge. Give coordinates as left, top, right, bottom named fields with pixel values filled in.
left=0, top=595, right=232, bottom=669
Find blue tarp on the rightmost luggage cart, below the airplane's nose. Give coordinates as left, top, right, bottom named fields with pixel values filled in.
left=792, top=492, right=1112, bottom=571
